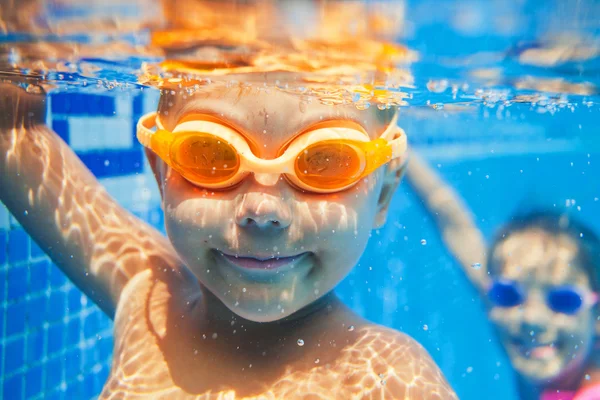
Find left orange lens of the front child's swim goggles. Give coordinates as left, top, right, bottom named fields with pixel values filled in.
left=171, top=133, right=240, bottom=184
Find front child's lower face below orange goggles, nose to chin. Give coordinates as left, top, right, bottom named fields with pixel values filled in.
left=161, top=158, right=381, bottom=320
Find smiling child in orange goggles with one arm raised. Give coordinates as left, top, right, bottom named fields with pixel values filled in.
left=0, top=9, right=456, bottom=399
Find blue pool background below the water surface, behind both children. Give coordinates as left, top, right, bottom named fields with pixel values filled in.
left=0, top=94, right=600, bottom=399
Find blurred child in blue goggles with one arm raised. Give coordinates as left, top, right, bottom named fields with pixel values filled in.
left=406, top=154, right=600, bottom=400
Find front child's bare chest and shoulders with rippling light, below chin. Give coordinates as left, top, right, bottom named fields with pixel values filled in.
left=101, top=272, right=455, bottom=400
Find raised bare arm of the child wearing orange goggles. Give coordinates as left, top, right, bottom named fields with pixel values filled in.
left=0, top=84, right=178, bottom=317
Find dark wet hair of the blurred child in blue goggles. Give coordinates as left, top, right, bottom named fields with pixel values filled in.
left=487, top=210, right=600, bottom=292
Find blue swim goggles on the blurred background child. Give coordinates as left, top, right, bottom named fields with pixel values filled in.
left=487, top=279, right=598, bottom=315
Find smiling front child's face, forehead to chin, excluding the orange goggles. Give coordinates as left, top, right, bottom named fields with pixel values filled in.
left=148, top=86, right=402, bottom=321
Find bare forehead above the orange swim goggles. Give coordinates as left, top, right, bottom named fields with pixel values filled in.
left=159, top=81, right=395, bottom=145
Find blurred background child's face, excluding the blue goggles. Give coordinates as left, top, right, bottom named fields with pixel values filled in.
left=490, top=229, right=595, bottom=381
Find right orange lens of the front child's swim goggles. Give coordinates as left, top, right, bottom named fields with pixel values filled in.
left=295, top=141, right=365, bottom=189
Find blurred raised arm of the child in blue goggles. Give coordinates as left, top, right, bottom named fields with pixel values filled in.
left=406, top=152, right=488, bottom=291
